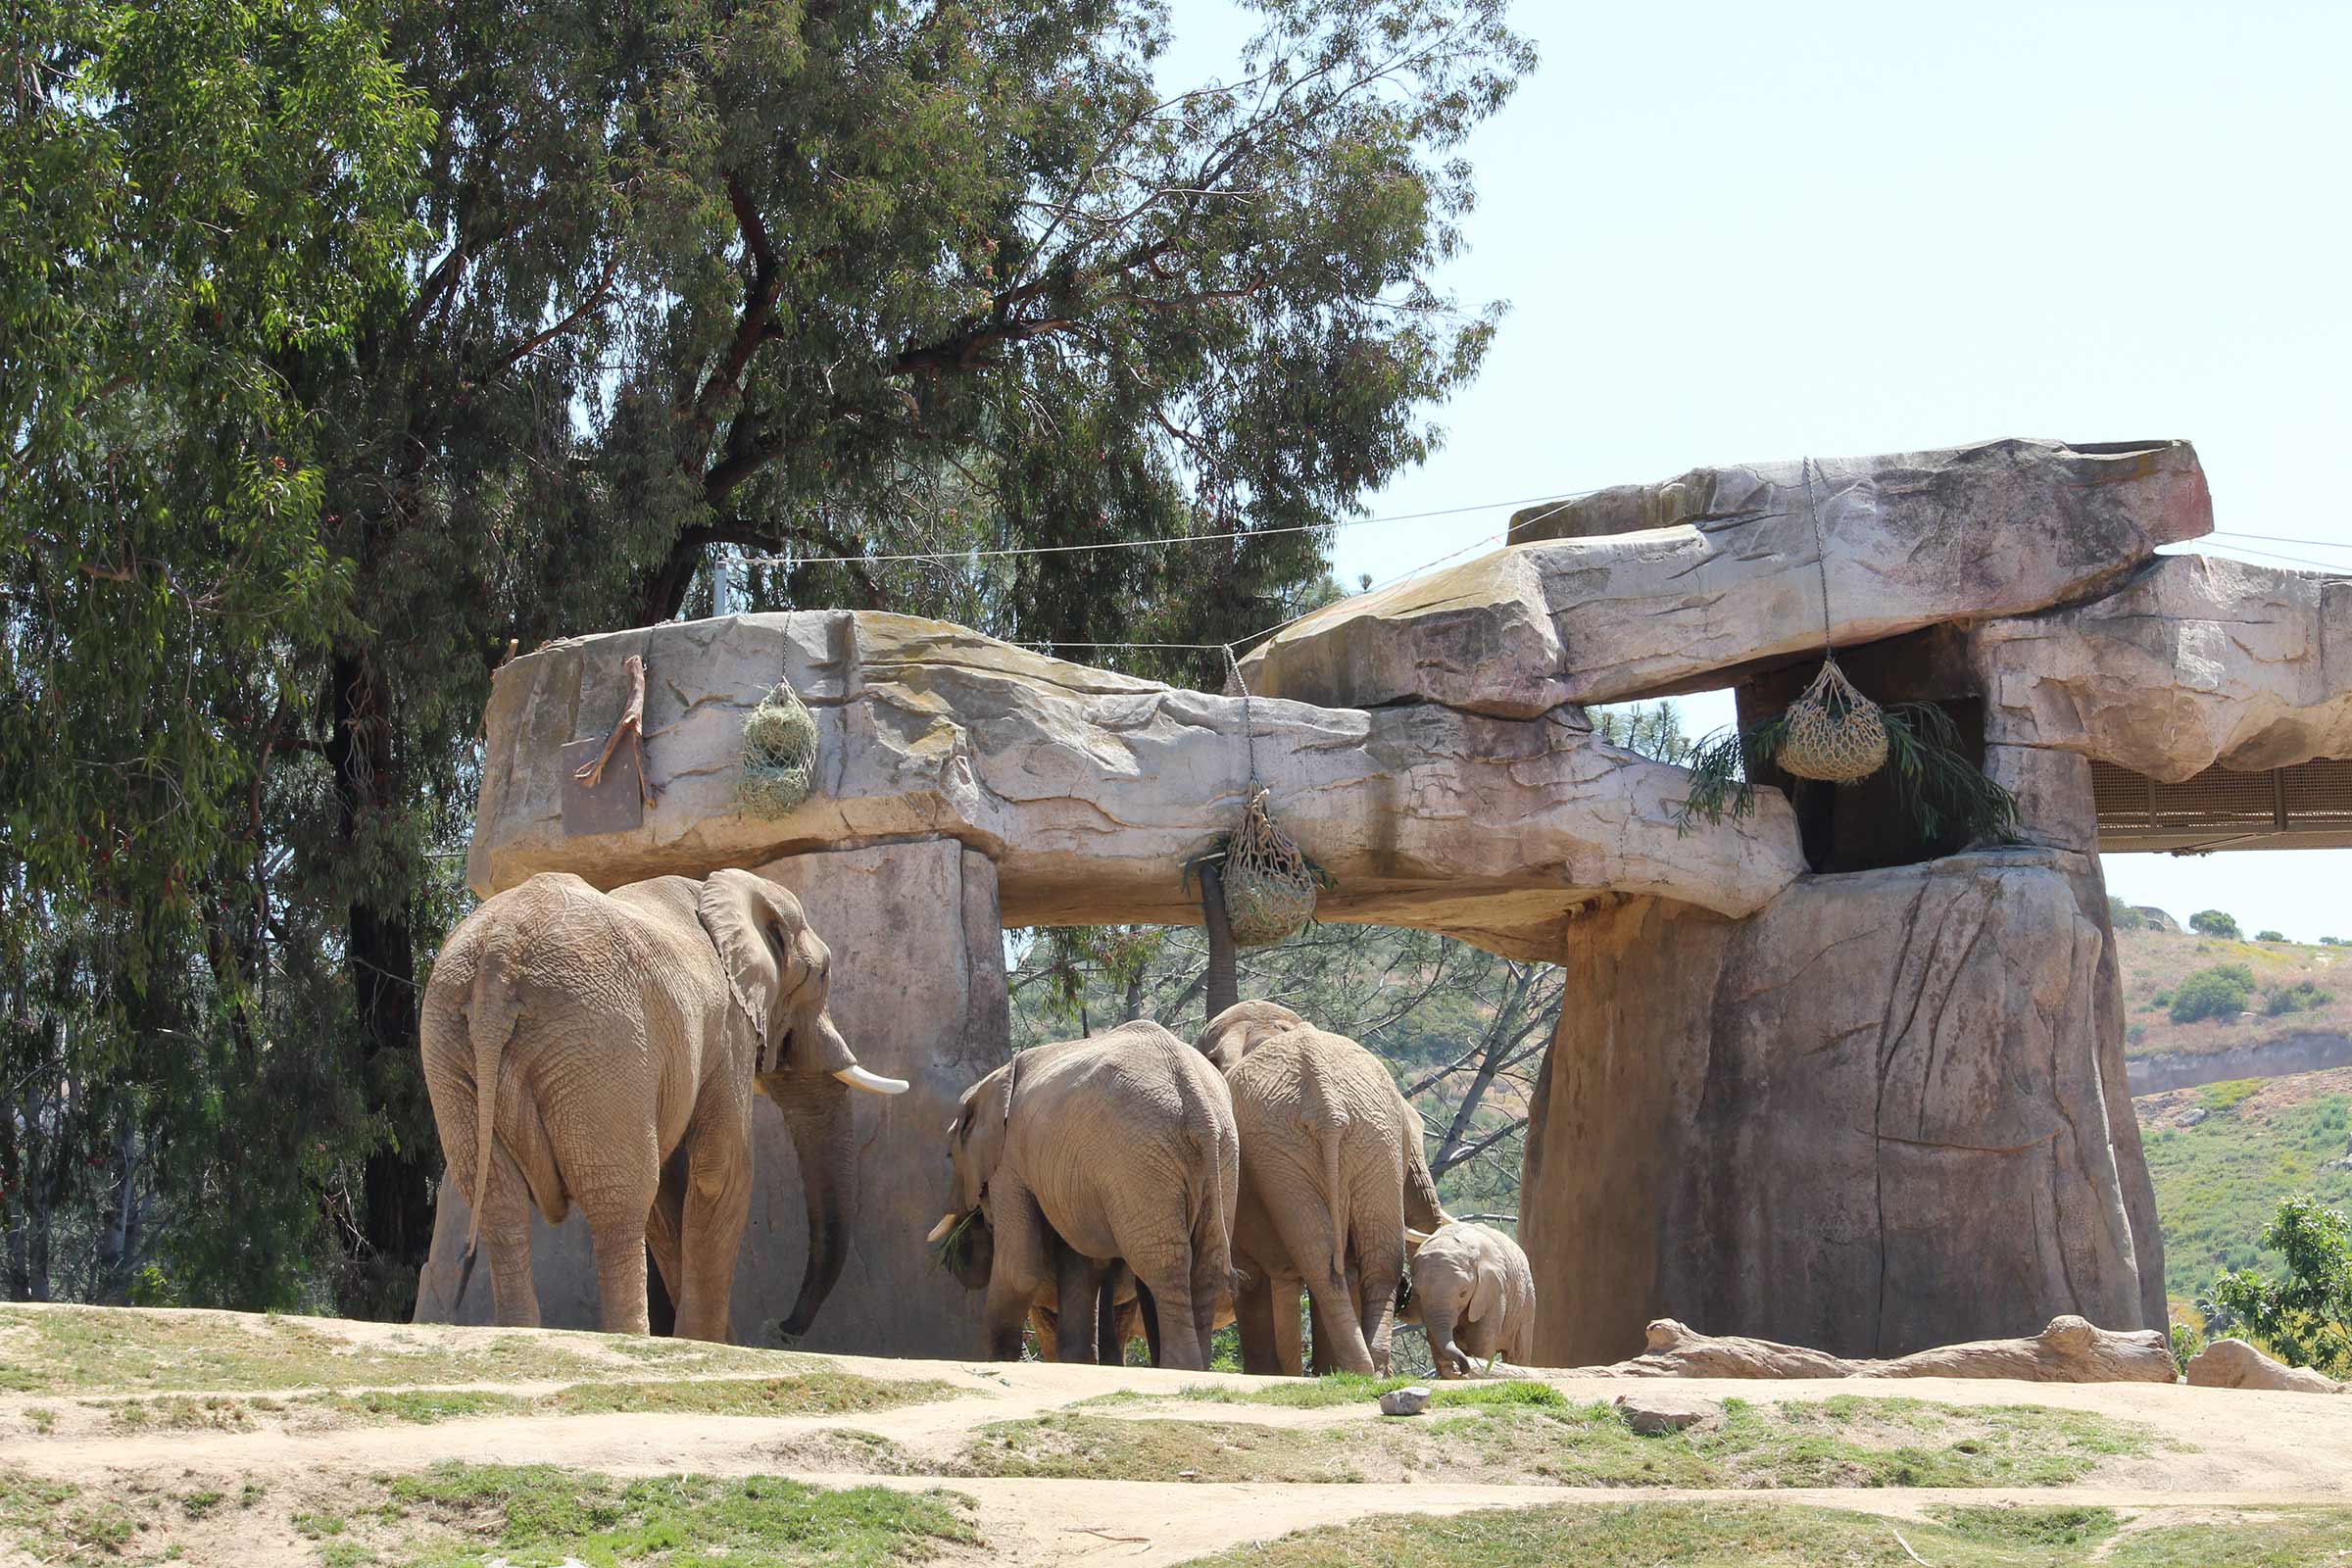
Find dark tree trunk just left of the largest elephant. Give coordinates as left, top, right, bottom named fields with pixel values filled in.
left=327, top=654, right=437, bottom=1319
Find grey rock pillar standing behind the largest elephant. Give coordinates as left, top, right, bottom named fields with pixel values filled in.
left=416, top=839, right=1011, bottom=1356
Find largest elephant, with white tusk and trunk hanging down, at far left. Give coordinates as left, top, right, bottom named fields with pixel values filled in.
left=421, top=870, right=906, bottom=1340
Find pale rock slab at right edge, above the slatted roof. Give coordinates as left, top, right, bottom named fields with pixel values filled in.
left=1969, top=555, right=2352, bottom=783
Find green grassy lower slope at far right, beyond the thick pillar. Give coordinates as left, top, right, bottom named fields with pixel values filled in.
left=2142, top=1079, right=2352, bottom=1300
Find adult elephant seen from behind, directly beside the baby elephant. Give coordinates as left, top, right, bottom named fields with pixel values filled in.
left=1200, top=1002, right=1446, bottom=1378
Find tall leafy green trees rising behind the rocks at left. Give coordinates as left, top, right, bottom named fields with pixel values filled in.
left=0, top=0, right=1534, bottom=1314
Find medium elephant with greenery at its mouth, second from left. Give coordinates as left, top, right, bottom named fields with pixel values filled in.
left=929, top=1022, right=1242, bottom=1371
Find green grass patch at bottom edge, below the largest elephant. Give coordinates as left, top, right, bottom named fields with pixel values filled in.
left=390, top=1464, right=978, bottom=1568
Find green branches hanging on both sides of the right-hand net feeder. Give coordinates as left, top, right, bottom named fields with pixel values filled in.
left=1677, top=703, right=2018, bottom=844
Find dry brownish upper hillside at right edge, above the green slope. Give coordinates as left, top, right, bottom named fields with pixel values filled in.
left=2115, top=929, right=2352, bottom=1093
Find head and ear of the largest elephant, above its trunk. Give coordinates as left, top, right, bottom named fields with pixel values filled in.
left=696, top=870, right=857, bottom=1072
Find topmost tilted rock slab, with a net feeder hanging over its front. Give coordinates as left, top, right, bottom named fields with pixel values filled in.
left=1242, top=440, right=2213, bottom=717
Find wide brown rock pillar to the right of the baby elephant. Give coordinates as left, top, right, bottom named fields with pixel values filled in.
left=1519, top=851, right=2164, bottom=1366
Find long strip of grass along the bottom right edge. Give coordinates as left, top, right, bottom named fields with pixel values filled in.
left=1176, top=1502, right=2352, bottom=1568
